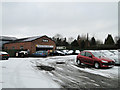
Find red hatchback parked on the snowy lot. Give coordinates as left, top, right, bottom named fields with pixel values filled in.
left=76, top=51, right=115, bottom=68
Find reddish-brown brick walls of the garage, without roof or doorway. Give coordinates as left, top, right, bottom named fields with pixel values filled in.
left=4, top=36, right=56, bottom=54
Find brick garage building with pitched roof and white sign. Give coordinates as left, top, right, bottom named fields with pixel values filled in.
left=4, top=35, right=56, bottom=54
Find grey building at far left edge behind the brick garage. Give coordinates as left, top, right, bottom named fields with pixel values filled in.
left=0, top=36, right=17, bottom=50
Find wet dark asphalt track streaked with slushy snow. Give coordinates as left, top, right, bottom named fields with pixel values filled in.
left=35, top=58, right=120, bottom=90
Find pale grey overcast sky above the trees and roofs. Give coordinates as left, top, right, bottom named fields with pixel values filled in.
left=2, top=2, right=118, bottom=41
